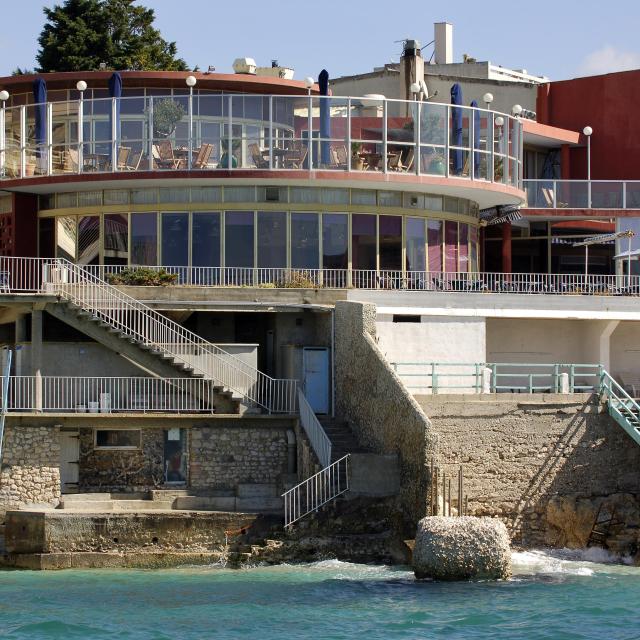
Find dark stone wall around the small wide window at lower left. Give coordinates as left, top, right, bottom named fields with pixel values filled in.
left=78, top=428, right=164, bottom=492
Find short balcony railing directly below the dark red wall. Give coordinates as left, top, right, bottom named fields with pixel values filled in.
left=523, top=179, right=640, bottom=209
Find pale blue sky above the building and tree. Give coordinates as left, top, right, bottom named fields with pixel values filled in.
left=0, top=0, right=640, bottom=80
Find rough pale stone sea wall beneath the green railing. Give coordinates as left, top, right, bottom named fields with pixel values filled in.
left=419, top=394, right=640, bottom=546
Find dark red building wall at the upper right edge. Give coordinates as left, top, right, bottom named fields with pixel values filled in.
left=537, top=70, right=640, bottom=180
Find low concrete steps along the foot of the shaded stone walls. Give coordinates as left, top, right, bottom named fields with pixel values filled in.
left=58, top=483, right=283, bottom=514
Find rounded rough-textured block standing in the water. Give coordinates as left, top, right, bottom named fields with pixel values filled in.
left=413, top=516, right=511, bottom=580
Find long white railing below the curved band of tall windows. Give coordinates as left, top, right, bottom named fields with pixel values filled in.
left=84, top=265, right=640, bottom=295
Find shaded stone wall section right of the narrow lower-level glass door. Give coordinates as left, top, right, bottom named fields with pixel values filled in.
left=189, top=423, right=291, bottom=490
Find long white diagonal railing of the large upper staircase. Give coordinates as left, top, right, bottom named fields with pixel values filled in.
left=43, top=258, right=297, bottom=413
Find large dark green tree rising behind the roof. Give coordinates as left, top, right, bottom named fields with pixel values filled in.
left=36, top=0, right=187, bottom=72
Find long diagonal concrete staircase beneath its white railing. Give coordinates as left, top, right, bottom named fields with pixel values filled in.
left=46, top=300, right=242, bottom=414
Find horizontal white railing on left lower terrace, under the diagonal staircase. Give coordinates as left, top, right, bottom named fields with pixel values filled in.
left=0, top=376, right=220, bottom=413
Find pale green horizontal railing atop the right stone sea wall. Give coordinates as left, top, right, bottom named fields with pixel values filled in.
left=391, top=362, right=603, bottom=394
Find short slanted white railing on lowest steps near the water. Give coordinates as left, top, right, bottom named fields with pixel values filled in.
left=282, top=454, right=350, bottom=528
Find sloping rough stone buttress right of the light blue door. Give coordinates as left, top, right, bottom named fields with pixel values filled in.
left=335, top=302, right=435, bottom=531
